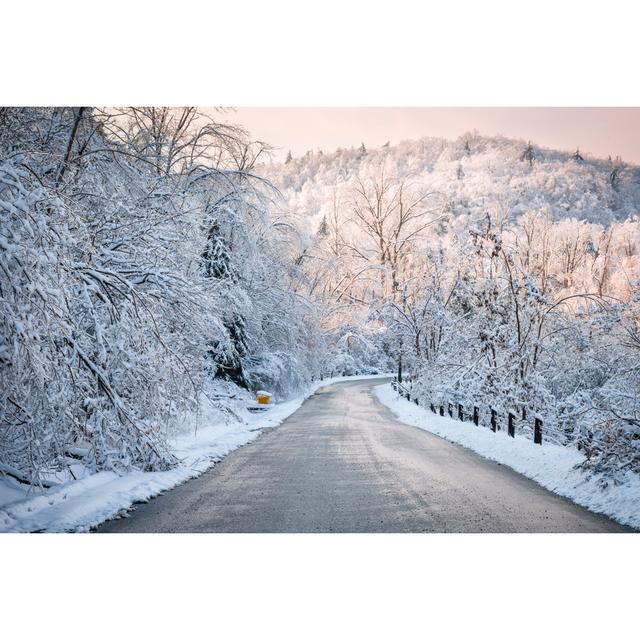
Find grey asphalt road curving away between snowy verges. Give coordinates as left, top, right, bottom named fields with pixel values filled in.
left=98, top=379, right=630, bottom=533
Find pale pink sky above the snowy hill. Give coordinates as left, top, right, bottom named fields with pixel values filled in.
left=227, top=107, right=640, bottom=164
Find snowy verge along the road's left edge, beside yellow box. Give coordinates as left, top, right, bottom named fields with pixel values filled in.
left=0, top=376, right=388, bottom=532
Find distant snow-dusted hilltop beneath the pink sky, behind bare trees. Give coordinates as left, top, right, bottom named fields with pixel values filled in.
left=262, top=133, right=640, bottom=226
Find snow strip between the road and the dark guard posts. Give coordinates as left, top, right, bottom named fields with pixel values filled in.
left=374, top=384, right=640, bottom=529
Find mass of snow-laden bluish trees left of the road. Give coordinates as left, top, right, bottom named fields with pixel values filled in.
left=0, top=107, right=321, bottom=482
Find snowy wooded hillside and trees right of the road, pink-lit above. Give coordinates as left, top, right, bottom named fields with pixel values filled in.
left=262, top=134, right=640, bottom=478
